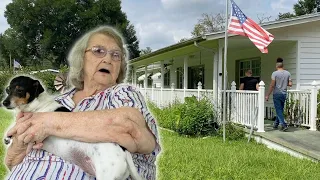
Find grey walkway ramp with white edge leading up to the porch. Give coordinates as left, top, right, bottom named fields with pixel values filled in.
left=247, top=123, right=320, bottom=162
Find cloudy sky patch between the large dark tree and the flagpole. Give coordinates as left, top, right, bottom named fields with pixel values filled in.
left=122, top=0, right=224, bottom=50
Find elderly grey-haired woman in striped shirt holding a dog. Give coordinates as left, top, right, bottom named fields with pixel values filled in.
left=5, top=26, right=160, bottom=180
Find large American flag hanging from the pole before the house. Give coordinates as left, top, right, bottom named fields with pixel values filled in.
left=228, top=0, right=274, bottom=53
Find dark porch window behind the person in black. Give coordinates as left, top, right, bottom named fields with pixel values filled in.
left=235, top=57, right=261, bottom=88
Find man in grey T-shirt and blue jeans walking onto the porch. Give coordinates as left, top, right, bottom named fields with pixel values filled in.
left=266, top=58, right=292, bottom=131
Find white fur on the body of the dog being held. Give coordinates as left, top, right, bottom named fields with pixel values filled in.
left=8, top=92, right=143, bottom=180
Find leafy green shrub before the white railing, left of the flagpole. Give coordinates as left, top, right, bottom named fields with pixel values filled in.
left=148, top=96, right=217, bottom=136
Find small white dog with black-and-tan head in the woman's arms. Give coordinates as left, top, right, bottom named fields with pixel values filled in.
left=3, top=76, right=142, bottom=180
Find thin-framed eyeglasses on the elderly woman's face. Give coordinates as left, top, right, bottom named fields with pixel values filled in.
left=85, top=46, right=122, bottom=61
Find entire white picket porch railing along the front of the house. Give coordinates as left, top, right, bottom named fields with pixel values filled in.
left=136, top=81, right=318, bottom=132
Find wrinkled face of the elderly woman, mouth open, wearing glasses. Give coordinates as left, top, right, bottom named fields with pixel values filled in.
left=84, top=34, right=122, bottom=88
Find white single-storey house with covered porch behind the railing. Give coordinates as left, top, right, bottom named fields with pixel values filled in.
left=130, top=13, right=320, bottom=131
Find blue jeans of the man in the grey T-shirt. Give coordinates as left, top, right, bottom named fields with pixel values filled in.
left=273, top=94, right=287, bottom=127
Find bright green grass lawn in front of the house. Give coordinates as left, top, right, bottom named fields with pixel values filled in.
left=0, top=109, right=320, bottom=180
